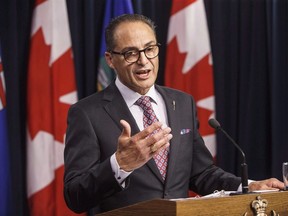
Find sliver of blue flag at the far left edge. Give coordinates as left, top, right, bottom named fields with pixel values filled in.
left=0, top=43, right=10, bottom=215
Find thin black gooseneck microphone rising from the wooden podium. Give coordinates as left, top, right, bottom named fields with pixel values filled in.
left=208, top=118, right=249, bottom=194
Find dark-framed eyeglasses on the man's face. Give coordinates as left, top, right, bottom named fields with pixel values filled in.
left=110, top=43, right=161, bottom=63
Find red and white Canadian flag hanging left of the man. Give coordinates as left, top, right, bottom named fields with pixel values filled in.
left=27, top=0, right=77, bottom=216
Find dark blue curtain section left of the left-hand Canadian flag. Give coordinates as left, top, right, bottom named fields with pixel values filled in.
left=0, top=0, right=33, bottom=216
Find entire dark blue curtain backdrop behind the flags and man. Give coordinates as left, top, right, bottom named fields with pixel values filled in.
left=0, top=0, right=288, bottom=216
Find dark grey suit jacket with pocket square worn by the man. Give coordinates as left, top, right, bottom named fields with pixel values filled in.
left=64, top=83, right=241, bottom=212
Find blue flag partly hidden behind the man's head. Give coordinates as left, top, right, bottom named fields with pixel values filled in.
left=97, top=0, right=133, bottom=91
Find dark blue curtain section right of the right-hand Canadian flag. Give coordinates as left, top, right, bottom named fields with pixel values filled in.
left=206, top=0, right=288, bottom=179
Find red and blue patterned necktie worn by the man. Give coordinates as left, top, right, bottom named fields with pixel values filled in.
left=135, top=96, right=168, bottom=180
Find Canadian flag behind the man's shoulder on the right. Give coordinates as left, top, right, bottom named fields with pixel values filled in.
left=165, top=0, right=216, bottom=157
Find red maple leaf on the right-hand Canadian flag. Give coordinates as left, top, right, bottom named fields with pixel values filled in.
left=165, top=38, right=214, bottom=135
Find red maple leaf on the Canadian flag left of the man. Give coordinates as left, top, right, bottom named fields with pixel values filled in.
left=27, top=28, right=76, bottom=143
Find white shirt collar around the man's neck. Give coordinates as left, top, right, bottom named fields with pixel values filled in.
left=115, top=77, right=158, bottom=108
